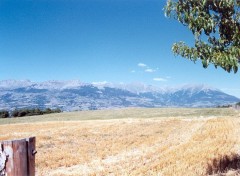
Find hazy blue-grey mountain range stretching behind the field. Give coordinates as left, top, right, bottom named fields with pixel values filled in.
left=0, top=80, right=240, bottom=111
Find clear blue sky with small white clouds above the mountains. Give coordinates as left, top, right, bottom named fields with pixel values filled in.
left=0, top=0, right=240, bottom=97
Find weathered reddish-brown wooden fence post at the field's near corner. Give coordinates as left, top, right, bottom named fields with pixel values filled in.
left=0, top=137, right=36, bottom=176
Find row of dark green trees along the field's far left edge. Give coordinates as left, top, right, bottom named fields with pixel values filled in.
left=0, top=108, right=62, bottom=118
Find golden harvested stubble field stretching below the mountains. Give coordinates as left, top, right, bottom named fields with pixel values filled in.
left=0, top=108, right=240, bottom=176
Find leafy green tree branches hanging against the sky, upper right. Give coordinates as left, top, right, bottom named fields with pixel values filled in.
left=165, top=0, right=240, bottom=73
